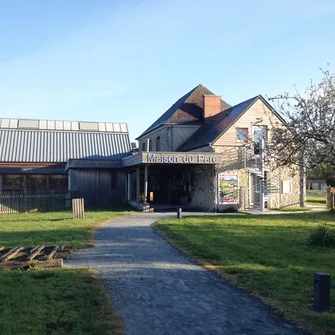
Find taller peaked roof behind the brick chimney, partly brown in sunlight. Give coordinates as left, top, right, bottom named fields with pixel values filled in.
left=137, top=85, right=230, bottom=139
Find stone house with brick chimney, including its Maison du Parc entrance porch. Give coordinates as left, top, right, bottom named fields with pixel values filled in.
left=128, top=85, right=300, bottom=211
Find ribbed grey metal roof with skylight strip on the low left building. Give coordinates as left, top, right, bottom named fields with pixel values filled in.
left=0, top=119, right=131, bottom=163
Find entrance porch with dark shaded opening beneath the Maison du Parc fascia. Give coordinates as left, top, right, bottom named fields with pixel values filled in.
left=123, top=152, right=222, bottom=208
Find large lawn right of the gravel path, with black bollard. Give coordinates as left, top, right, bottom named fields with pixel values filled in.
left=154, top=212, right=335, bottom=335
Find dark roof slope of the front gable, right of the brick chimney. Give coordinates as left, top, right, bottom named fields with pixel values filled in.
left=178, top=95, right=262, bottom=151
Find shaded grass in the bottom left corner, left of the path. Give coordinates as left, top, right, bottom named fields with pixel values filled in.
left=0, top=269, right=123, bottom=335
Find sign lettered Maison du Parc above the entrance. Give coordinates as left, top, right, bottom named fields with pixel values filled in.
left=143, top=152, right=219, bottom=164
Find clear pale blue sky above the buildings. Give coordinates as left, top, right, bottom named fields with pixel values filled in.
left=0, top=0, right=335, bottom=139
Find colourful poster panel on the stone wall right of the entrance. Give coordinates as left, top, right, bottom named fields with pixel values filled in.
left=218, top=173, right=239, bottom=205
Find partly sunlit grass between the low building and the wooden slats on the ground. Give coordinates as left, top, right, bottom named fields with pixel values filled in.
left=0, top=208, right=131, bottom=249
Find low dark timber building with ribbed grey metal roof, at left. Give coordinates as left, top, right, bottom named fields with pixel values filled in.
left=0, top=118, right=131, bottom=209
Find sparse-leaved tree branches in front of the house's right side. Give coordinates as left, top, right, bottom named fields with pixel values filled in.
left=267, top=70, right=335, bottom=170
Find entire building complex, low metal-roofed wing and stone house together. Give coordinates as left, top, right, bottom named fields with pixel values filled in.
left=0, top=85, right=300, bottom=211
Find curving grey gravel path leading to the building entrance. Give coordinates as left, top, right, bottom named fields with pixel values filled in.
left=67, top=213, right=301, bottom=335
